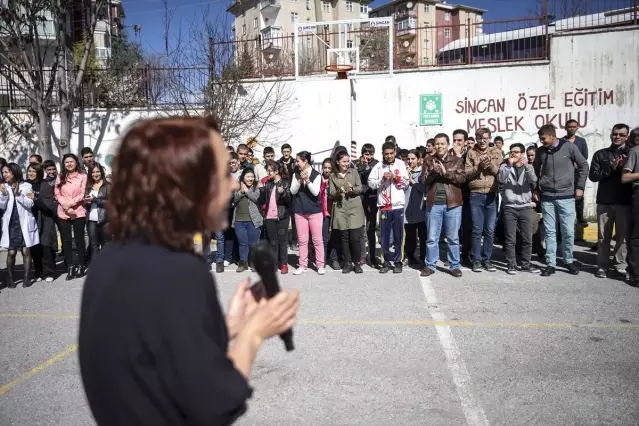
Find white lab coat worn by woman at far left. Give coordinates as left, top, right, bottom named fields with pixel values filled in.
left=0, top=182, right=40, bottom=248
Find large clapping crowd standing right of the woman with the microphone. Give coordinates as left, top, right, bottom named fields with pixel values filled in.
left=212, top=120, right=639, bottom=286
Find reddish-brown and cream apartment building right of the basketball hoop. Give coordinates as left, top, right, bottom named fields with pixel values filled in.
left=370, top=0, right=487, bottom=68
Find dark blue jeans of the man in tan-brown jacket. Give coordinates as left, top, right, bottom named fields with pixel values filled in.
left=470, top=192, right=497, bottom=262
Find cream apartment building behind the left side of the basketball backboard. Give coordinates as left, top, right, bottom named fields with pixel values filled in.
left=227, top=0, right=371, bottom=70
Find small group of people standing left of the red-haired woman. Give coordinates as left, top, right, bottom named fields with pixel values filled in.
left=0, top=147, right=110, bottom=288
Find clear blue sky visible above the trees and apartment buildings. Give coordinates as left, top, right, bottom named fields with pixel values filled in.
left=122, top=0, right=538, bottom=58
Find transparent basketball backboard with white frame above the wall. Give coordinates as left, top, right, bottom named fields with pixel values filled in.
left=294, top=17, right=393, bottom=80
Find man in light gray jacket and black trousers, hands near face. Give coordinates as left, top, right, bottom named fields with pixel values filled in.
left=498, top=143, right=539, bottom=275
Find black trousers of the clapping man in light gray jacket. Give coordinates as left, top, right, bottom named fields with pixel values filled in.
left=502, top=207, right=533, bottom=267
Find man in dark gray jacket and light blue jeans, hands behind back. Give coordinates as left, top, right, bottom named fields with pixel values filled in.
left=533, top=124, right=588, bottom=277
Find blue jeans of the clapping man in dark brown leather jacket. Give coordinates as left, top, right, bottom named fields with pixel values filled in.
left=424, top=204, right=462, bottom=271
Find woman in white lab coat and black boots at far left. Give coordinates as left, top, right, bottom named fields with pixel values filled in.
left=0, top=163, right=40, bottom=288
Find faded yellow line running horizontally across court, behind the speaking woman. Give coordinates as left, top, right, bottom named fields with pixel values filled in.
left=0, top=312, right=639, bottom=329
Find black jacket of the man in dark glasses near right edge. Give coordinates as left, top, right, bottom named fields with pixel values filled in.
left=588, top=146, right=632, bottom=206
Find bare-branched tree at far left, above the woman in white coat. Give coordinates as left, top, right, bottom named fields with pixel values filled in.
left=0, top=0, right=106, bottom=158
